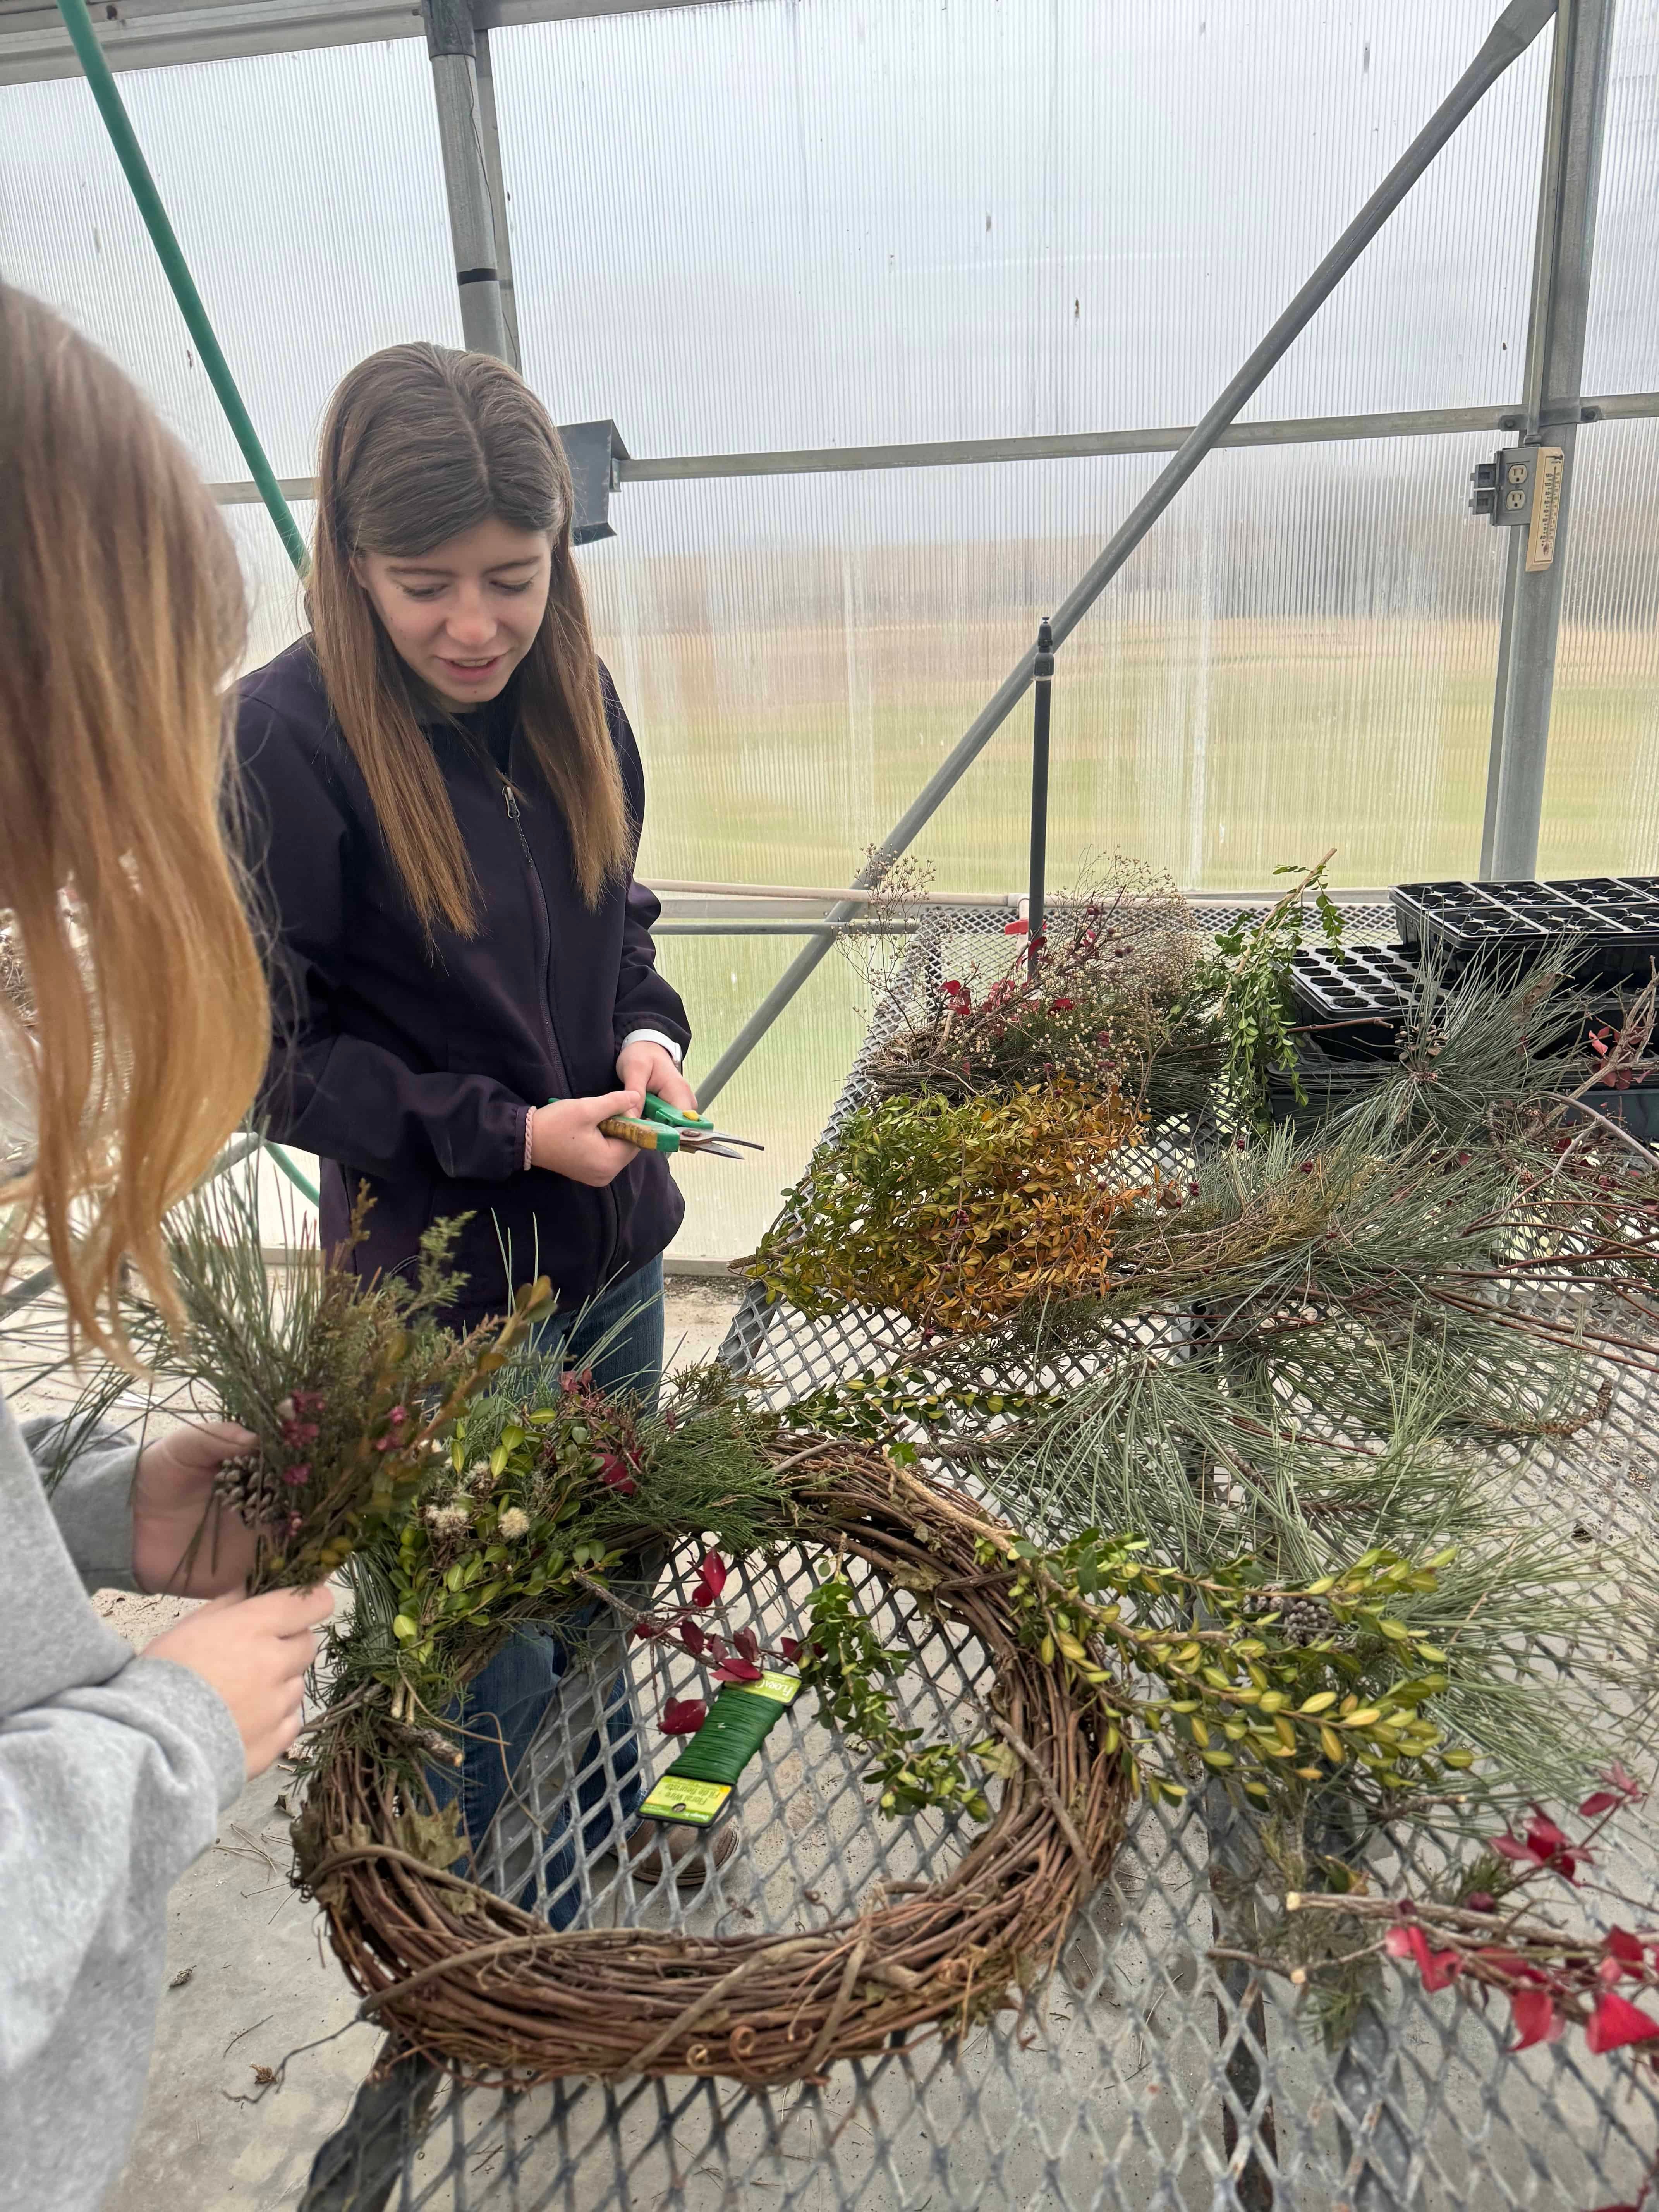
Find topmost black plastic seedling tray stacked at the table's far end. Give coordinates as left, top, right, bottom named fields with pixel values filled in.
left=1391, top=876, right=1659, bottom=982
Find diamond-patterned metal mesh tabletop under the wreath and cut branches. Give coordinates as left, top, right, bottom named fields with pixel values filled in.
left=303, top=907, right=1659, bottom=2212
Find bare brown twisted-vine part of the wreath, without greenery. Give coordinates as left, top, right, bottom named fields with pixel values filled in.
left=296, top=1438, right=1130, bottom=2088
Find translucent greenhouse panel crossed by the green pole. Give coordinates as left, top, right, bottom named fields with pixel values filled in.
left=0, top=40, right=460, bottom=480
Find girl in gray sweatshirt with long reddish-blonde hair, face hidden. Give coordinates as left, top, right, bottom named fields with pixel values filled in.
left=0, top=285, right=330, bottom=2212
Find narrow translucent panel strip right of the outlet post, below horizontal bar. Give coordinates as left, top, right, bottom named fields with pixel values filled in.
left=1537, top=418, right=1659, bottom=876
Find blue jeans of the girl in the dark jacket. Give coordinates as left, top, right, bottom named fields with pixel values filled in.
left=427, top=1259, right=664, bottom=1929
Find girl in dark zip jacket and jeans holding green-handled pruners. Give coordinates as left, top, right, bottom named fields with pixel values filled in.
left=237, top=345, right=730, bottom=1924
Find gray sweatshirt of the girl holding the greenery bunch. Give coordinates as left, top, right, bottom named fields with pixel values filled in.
left=0, top=1400, right=243, bottom=2212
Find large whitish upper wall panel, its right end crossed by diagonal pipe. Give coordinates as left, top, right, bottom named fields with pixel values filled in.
left=491, top=0, right=1548, bottom=453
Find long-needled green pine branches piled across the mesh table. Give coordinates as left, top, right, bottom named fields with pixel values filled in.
left=761, top=971, right=1659, bottom=1829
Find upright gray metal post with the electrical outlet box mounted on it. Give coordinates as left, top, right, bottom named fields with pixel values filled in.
left=1480, top=0, right=1613, bottom=880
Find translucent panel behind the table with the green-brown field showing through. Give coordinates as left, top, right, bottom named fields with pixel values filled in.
left=584, top=431, right=1522, bottom=911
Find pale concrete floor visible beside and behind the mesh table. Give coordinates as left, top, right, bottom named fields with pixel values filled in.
left=13, top=1279, right=737, bottom=2212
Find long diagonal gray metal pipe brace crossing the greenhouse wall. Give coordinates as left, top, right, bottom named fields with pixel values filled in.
left=699, top=0, right=1555, bottom=1104
